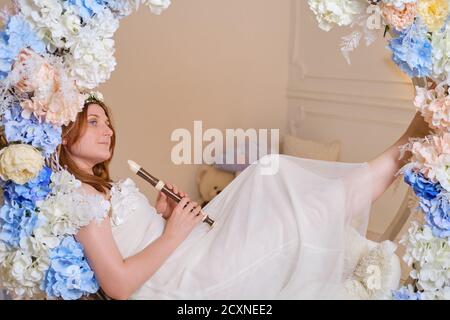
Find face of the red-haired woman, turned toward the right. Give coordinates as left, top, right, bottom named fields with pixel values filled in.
left=63, top=104, right=113, bottom=170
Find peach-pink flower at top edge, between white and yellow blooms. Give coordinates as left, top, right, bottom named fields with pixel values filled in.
left=381, top=2, right=417, bottom=30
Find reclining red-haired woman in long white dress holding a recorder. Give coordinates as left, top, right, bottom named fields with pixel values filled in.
left=60, top=97, right=428, bottom=299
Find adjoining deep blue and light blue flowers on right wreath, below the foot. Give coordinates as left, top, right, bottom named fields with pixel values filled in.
left=404, top=170, right=450, bottom=238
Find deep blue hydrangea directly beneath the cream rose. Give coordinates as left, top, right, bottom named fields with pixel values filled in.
left=0, top=166, right=52, bottom=205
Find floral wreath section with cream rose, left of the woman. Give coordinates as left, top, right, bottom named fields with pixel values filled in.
left=0, top=0, right=170, bottom=299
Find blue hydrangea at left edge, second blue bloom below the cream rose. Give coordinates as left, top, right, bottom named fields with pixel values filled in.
left=0, top=201, right=38, bottom=248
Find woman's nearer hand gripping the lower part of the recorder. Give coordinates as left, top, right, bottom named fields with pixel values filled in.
left=163, top=197, right=203, bottom=242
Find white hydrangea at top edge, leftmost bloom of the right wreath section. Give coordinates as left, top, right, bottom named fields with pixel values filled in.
left=308, top=0, right=369, bottom=31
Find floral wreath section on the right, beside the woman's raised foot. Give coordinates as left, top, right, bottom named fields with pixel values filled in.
left=308, top=0, right=450, bottom=300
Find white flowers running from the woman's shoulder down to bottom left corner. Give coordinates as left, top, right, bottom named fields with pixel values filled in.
left=0, top=170, right=110, bottom=299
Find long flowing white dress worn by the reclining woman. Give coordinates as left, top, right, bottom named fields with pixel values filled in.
left=111, top=155, right=399, bottom=299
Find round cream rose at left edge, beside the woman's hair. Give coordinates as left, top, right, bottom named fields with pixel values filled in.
left=0, top=144, right=44, bottom=184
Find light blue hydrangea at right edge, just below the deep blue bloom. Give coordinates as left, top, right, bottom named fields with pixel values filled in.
left=419, top=194, right=450, bottom=238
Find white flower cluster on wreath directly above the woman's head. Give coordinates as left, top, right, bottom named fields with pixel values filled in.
left=19, top=0, right=119, bottom=90
